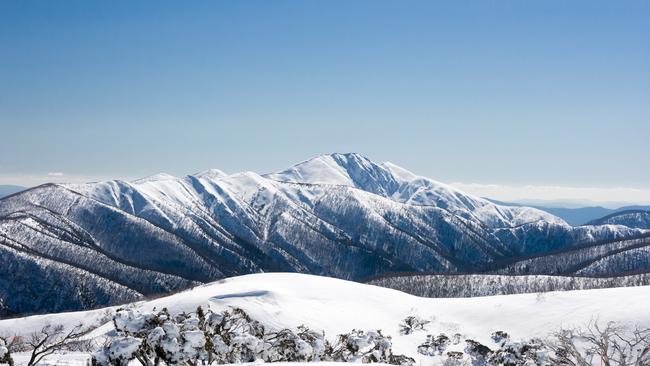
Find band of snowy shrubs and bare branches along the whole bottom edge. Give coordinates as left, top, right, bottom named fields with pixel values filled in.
left=0, top=306, right=650, bottom=366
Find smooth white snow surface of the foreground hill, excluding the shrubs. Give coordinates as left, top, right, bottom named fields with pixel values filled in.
left=0, top=273, right=650, bottom=360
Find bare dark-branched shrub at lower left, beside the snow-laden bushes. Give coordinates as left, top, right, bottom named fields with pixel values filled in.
left=25, top=324, right=88, bottom=366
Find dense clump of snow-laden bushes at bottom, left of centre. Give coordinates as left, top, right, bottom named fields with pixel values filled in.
left=93, top=307, right=414, bottom=366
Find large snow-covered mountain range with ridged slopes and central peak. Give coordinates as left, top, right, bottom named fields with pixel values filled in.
left=0, top=154, right=648, bottom=316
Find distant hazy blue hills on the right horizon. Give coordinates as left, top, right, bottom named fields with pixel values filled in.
left=488, top=199, right=650, bottom=226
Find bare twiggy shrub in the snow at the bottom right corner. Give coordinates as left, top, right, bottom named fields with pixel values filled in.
left=549, top=321, right=650, bottom=366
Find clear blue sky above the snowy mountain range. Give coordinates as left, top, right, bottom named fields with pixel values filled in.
left=0, top=0, right=650, bottom=203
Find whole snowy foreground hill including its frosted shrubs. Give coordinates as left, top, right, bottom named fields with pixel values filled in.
left=0, top=273, right=650, bottom=366
